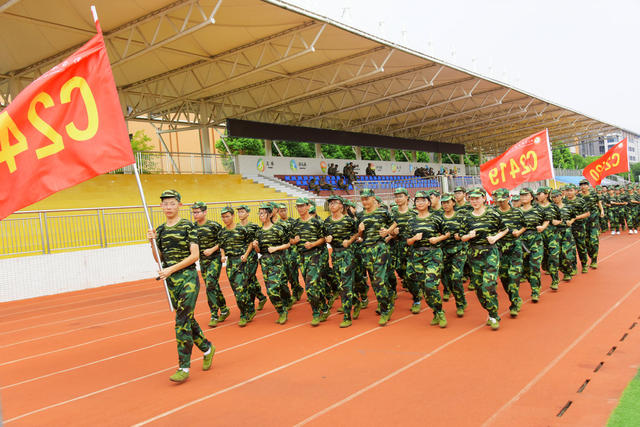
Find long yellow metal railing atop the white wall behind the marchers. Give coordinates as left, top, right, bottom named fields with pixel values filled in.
left=0, top=198, right=298, bottom=258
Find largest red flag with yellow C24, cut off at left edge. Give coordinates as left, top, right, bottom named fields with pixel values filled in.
left=0, top=21, right=134, bottom=219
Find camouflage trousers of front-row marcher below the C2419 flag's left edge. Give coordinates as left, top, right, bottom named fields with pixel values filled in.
left=467, top=245, right=500, bottom=320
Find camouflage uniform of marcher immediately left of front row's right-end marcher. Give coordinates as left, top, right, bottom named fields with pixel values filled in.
left=442, top=211, right=468, bottom=309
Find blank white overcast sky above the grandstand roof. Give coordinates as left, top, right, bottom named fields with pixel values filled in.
left=285, top=0, right=640, bottom=134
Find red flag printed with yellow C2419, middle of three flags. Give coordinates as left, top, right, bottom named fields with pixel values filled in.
left=480, top=129, right=554, bottom=193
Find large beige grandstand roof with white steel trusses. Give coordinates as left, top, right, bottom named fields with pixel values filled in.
left=0, top=0, right=615, bottom=154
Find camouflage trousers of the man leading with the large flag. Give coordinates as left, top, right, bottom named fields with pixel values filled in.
left=167, top=268, right=211, bottom=368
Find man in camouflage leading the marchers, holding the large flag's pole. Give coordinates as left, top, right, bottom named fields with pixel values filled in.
left=147, top=190, right=215, bottom=383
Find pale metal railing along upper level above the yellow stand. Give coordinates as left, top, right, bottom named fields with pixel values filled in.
left=111, top=151, right=236, bottom=174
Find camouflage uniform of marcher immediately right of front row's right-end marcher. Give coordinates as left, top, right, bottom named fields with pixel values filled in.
left=496, top=208, right=525, bottom=310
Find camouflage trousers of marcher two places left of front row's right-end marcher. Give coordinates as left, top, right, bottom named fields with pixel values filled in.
left=407, top=247, right=442, bottom=314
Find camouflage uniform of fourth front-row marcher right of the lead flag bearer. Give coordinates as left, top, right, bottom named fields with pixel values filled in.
left=292, top=216, right=329, bottom=317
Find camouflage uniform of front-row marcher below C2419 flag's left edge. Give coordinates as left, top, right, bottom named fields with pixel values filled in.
left=462, top=208, right=505, bottom=320
